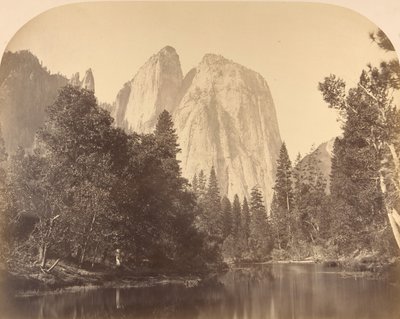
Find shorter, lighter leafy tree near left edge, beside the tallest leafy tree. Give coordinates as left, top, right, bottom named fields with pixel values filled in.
left=8, top=149, right=69, bottom=268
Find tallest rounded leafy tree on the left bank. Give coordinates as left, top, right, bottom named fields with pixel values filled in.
left=36, top=86, right=123, bottom=266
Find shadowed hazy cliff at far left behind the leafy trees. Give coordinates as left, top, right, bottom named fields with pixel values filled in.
left=0, top=51, right=68, bottom=153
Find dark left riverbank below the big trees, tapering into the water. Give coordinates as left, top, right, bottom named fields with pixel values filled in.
left=0, top=262, right=226, bottom=296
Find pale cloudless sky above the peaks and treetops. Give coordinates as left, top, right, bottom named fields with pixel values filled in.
left=7, top=2, right=393, bottom=160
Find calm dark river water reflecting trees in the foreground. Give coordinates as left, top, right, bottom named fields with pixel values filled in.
left=0, top=264, right=400, bottom=319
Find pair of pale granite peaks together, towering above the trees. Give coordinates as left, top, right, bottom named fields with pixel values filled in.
left=113, top=47, right=281, bottom=201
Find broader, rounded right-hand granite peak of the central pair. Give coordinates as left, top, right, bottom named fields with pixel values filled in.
left=174, top=54, right=281, bottom=204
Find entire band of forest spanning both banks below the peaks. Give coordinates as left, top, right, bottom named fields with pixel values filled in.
left=0, top=31, right=400, bottom=282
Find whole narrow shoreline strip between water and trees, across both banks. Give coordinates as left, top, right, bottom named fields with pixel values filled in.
left=4, top=255, right=400, bottom=297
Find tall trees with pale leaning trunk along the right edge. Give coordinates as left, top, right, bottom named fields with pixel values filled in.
left=319, top=30, right=400, bottom=256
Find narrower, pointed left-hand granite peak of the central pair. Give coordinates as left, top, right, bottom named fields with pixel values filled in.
left=113, top=46, right=183, bottom=133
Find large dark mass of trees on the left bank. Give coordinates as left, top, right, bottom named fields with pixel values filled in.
left=5, top=86, right=212, bottom=268
